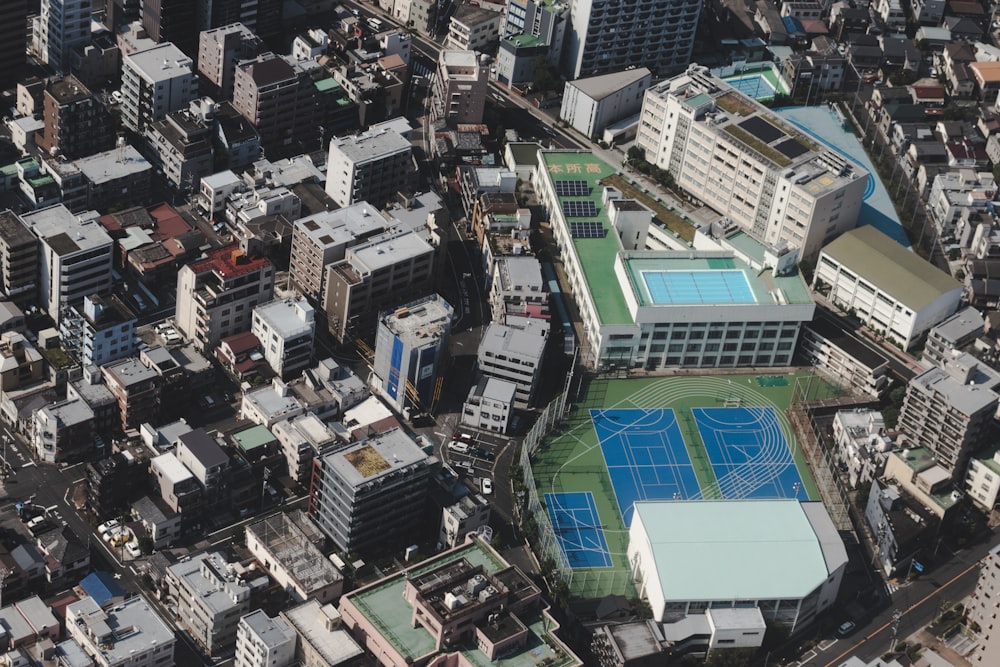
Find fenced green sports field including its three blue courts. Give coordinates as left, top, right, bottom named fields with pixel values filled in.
left=531, top=371, right=834, bottom=597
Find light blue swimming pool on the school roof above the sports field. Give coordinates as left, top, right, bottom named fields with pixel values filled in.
left=641, top=270, right=757, bottom=305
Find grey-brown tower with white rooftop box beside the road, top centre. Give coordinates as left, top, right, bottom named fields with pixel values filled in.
left=431, top=49, right=489, bottom=128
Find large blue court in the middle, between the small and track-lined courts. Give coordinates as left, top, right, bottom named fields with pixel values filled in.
left=590, top=408, right=701, bottom=526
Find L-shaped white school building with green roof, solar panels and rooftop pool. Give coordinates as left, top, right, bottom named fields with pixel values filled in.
left=534, top=150, right=815, bottom=370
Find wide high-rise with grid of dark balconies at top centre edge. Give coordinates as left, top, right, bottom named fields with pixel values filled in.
left=563, top=0, right=701, bottom=79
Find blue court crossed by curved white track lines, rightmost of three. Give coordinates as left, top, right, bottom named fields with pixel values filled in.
left=691, top=408, right=808, bottom=500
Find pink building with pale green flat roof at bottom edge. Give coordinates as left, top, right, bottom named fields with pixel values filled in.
left=340, top=537, right=583, bottom=667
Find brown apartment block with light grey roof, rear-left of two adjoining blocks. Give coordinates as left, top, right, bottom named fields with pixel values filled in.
left=288, top=202, right=388, bottom=301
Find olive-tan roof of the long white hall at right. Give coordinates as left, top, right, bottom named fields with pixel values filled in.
left=822, top=225, right=961, bottom=312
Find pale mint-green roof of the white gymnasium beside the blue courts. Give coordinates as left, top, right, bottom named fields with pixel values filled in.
left=632, top=500, right=847, bottom=601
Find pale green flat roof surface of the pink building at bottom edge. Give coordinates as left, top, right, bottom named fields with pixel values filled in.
left=346, top=538, right=579, bottom=667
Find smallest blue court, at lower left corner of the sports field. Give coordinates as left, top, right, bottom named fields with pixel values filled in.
left=545, top=491, right=611, bottom=568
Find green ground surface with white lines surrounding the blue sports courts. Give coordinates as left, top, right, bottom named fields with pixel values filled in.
left=531, top=371, right=836, bottom=598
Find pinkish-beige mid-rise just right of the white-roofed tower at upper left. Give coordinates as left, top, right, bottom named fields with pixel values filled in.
left=198, top=22, right=264, bottom=100
